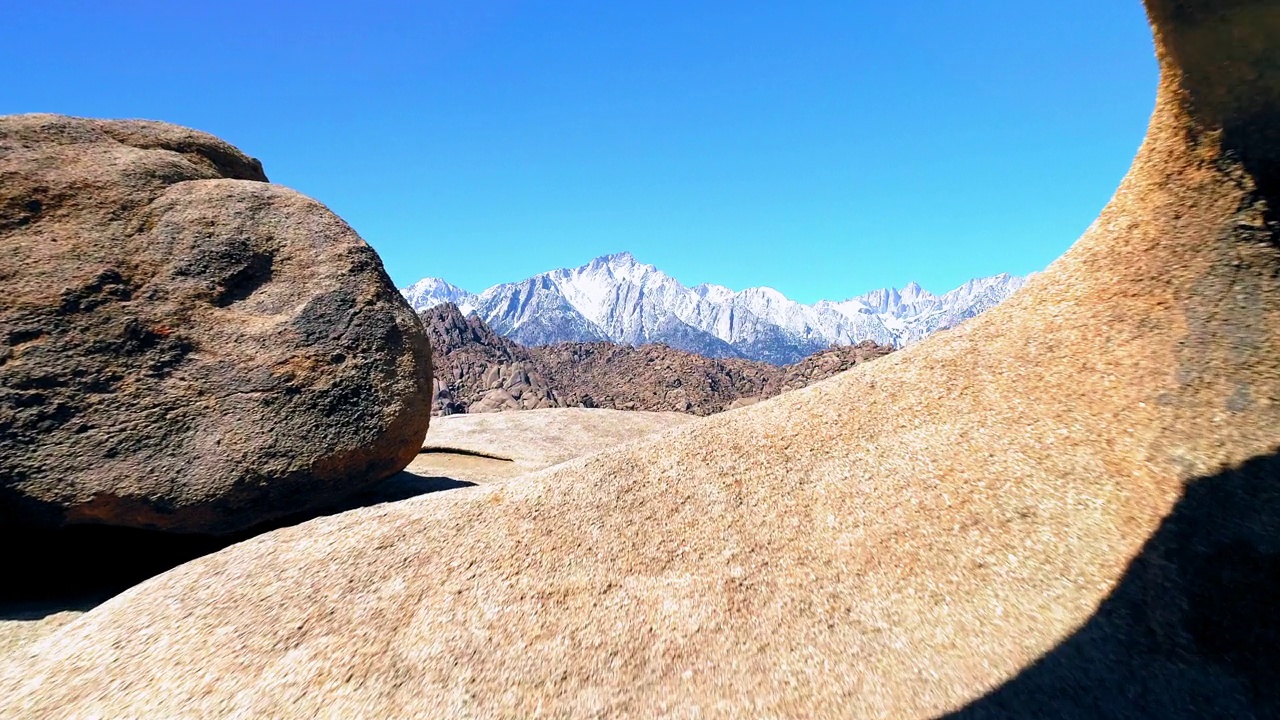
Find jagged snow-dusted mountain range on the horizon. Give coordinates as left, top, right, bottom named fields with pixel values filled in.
left=401, top=252, right=1025, bottom=364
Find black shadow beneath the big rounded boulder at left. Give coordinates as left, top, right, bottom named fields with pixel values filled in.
left=0, top=473, right=475, bottom=620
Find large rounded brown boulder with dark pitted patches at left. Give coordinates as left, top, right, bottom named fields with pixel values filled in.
left=0, top=115, right=431, bottom=533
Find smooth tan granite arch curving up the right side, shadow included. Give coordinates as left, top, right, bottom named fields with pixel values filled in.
left=0, top=0, right=1280, bottom=717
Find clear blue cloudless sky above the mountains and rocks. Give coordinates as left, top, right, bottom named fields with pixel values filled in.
left=0, top=0, right=1156, bottom=301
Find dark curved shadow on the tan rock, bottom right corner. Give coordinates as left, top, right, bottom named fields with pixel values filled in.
left=946, top=454, right=1280, bottom=720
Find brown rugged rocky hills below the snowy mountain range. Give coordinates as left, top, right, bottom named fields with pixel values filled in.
left=420, top=302, right=892, bottom=415
